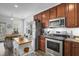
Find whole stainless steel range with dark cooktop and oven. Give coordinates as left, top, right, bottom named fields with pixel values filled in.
left=45, top=31, right=66, bottom=56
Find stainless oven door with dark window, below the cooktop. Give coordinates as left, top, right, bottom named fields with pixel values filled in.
left=46, top=38, right=63, bottom=56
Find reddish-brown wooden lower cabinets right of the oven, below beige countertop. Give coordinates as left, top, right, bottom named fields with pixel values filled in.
left=64, top=41, right=79, bottom=56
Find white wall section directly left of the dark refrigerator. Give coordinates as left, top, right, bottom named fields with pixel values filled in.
left=24, top=15, right=35, bottom=51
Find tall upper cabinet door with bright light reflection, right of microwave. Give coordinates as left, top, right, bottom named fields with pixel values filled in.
left=66, top=4, right=77, bottom=27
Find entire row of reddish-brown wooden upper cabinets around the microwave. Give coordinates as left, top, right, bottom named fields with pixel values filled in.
left=34, top=3, right=79, bottom=28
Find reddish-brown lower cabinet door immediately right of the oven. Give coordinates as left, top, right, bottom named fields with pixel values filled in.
left=64, top=41, right=71, bottom=56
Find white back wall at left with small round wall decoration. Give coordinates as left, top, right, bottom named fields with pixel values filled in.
left=0, top=15, right=24, bottom=34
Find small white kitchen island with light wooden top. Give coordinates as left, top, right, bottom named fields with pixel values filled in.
left=13, top=38, right=32, bottom=56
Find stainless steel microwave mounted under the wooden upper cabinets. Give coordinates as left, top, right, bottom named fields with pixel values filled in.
left=49, top=17, right=65, bottom=27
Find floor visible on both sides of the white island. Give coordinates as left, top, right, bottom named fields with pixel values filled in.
left=0, top=42, right=48, bottom=56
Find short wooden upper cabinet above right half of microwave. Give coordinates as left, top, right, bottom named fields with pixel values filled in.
left=57, top=3, right=66, bottom=17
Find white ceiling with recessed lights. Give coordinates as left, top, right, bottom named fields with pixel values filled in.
left=0, top=3, right=58, bottom=18
